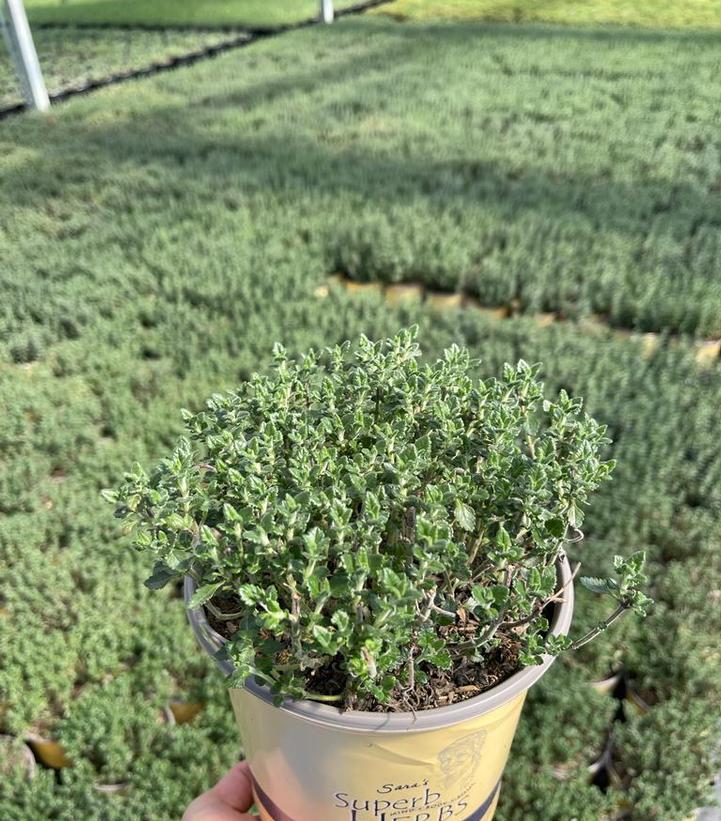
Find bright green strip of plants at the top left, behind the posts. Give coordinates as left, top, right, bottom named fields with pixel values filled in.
left=25, top=0, right=362, bottom=26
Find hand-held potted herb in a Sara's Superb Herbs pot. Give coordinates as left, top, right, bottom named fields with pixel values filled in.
left=107, top=329, right=648, bottom=821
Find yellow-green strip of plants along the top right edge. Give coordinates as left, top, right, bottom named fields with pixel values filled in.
left=380, top=0, right=721, bottom=28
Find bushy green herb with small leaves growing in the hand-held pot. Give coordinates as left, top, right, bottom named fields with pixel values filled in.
left=107, top=330, right=647, bottom=705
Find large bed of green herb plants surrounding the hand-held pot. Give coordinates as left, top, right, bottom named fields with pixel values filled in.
left=0, top=12, right=721, bottom=821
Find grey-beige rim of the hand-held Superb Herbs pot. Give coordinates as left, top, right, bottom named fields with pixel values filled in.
left=183, top=552, right=574, bottom=733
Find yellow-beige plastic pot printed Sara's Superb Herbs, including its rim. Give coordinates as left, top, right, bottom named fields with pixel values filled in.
left=185, top=557, right=573, bottom=821
